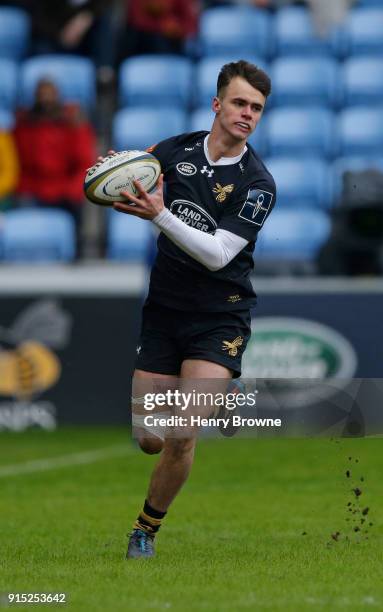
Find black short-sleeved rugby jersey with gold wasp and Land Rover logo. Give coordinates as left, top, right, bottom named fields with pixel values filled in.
left=148, top=132, right=275, bottom=312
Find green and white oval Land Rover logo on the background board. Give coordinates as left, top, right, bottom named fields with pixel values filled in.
left=243, top=317, right=357, bottom=408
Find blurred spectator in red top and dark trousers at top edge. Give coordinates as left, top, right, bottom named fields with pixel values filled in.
left=121, top=0, right=200, bottom=59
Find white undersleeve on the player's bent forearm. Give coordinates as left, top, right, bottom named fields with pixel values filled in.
left=153, top=208, right=249, bottom=272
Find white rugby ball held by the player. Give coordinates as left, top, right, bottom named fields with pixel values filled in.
left=84, top=151, right=161, bottom=206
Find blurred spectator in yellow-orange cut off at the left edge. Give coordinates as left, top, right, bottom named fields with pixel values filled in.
left=0, top=131, right=19, bottom=211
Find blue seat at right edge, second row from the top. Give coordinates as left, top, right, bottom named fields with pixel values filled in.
left=343, top=56, right=383, bottom=109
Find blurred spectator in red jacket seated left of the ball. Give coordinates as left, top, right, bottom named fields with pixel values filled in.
left=15, top=79, right=96, bottom=246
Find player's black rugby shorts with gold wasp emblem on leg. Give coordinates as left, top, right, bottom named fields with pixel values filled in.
left=135, top=303, right=251, bottom=378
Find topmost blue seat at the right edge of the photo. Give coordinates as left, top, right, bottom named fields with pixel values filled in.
left=344, top=5, right=383, bottom=56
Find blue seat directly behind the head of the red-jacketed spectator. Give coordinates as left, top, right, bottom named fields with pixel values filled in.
left=20, top=55, right=96, bottom=110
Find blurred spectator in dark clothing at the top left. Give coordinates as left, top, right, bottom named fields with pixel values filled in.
left=25, top=0, right=115, bottom=75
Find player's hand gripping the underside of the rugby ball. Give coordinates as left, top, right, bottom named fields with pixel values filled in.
left=113, top=174, right=165, bottom=221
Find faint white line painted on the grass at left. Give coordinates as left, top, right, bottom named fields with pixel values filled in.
left=0, top=444, right=133, bottom=478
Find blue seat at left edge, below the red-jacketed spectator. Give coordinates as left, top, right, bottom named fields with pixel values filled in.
left=3, top=209, right=75, bottom=263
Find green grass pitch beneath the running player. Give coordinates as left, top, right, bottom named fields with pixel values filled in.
left=0, top=428, right=383, bottom=612
